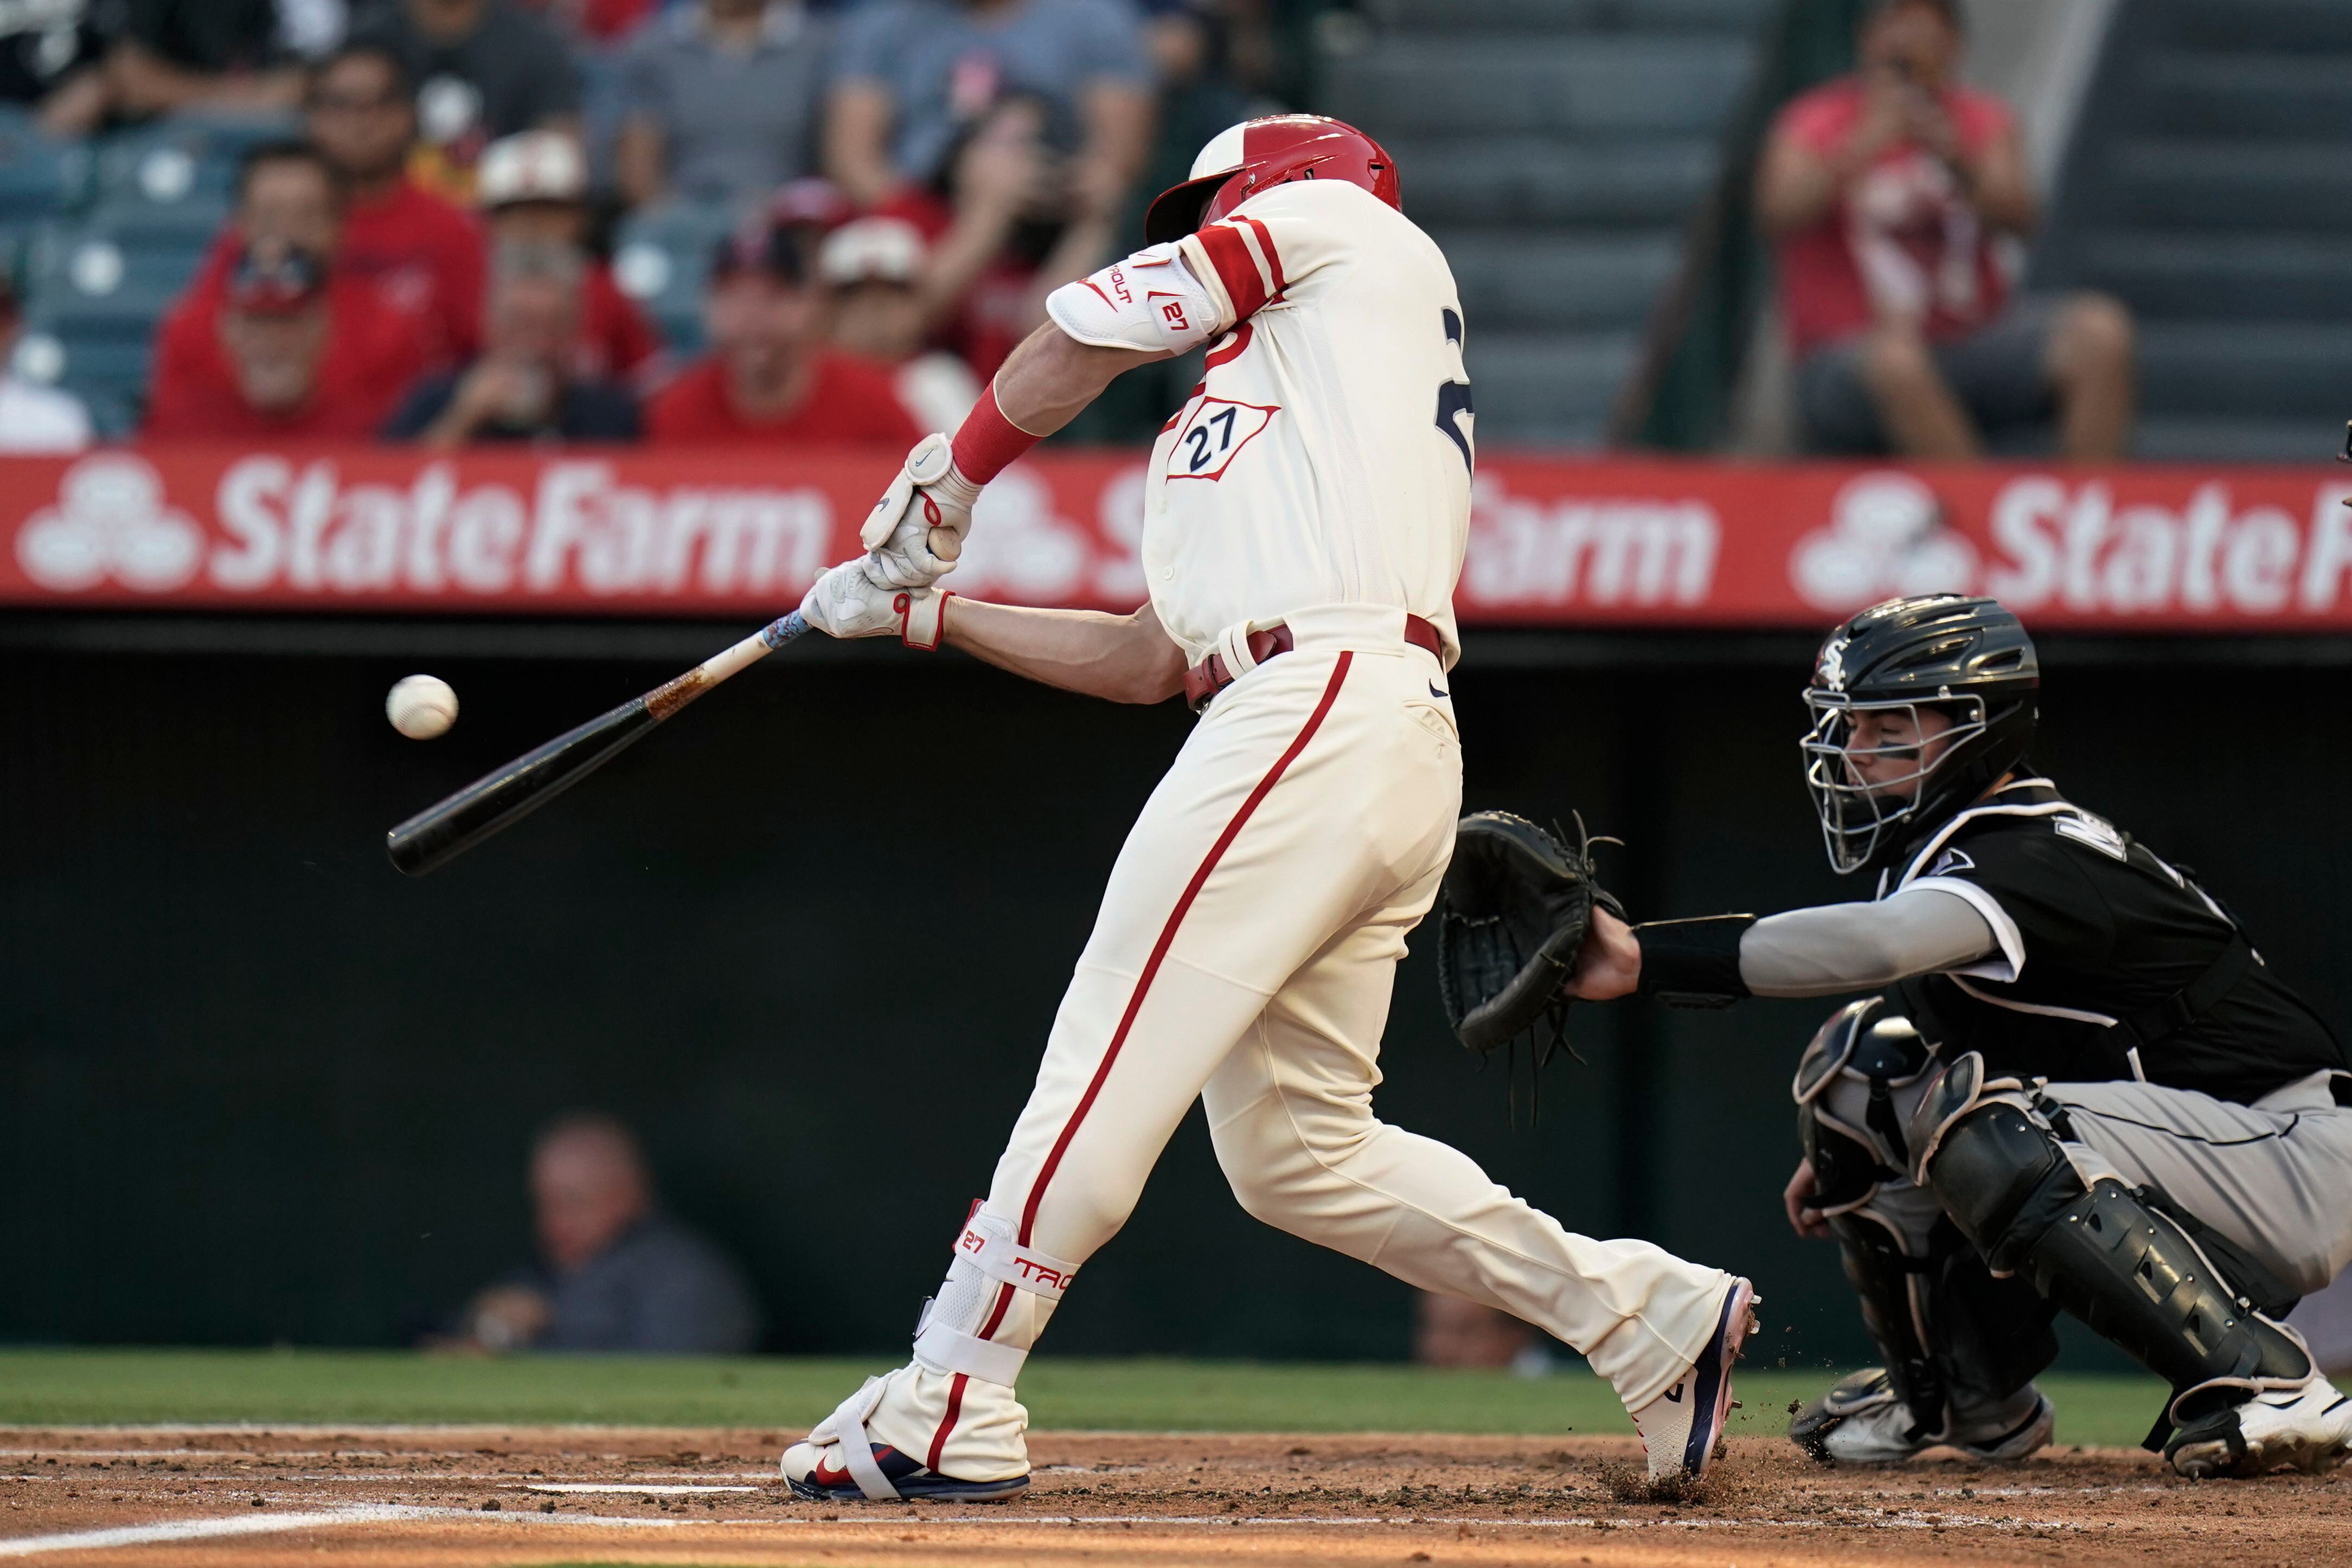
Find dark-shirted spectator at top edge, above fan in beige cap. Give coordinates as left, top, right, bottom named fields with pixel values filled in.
left=350, top=0, right=581, bottom=197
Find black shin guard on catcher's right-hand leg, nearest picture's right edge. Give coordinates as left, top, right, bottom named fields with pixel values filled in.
left=1914, top=1051, right=2317, bottom=1427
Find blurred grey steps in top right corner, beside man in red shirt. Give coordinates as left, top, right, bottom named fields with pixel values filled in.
left=2030, top=0, right=2352, bottom=461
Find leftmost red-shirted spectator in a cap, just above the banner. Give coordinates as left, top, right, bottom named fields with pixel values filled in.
left=144, top=240, right=416, bottom=442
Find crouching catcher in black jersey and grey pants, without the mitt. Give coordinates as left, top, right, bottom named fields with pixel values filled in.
left=1533, top=595, right=2352, bottom=1476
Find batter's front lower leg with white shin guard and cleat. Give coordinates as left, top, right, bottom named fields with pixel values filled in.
left=783, top=1204, right=1077, bottom=1502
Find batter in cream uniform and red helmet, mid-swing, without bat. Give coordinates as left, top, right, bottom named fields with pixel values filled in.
left=783, top=115, right=1752, bottom=1500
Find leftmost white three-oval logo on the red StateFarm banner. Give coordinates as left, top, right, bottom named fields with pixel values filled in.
left=16, top=451, right=204, bottom=593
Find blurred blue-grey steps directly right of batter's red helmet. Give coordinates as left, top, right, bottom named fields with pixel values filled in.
left=1324, top=0, right=1773, bottom=447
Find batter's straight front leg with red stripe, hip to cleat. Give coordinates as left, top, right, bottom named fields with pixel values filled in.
left=786, top=649, right=1460, bottom=1495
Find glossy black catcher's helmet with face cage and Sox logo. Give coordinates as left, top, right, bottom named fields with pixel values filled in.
left=1799, top=593, right=2042, bottom=875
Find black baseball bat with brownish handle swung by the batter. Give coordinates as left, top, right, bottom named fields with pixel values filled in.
left=383, top=609, right=809, bottom=877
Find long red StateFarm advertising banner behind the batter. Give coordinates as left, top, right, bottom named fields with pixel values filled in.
left=0, top=447, right=2352, bottom=632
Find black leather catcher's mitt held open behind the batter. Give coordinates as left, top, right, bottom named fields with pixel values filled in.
left=1437, top=811, right=1625, bottom=1056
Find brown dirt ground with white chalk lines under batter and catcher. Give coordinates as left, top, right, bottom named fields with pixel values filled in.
left=0, top=1422, right=2352, bottom=1568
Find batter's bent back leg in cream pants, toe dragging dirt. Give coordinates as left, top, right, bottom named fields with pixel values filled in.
left=1204, top=867, right=1745, bottom=1469
